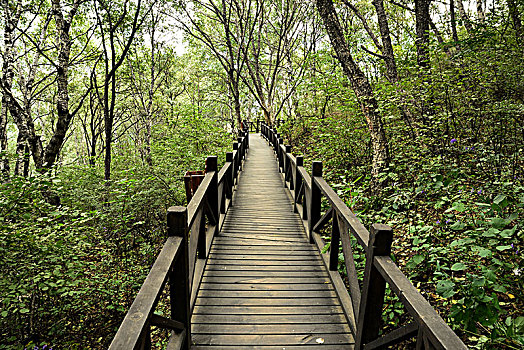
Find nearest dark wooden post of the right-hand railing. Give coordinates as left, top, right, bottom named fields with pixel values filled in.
left=355, top=224, right=393, bottom=349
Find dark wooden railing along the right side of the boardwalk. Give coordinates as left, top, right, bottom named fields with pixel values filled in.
left=261, top=123, right=467, bottom=349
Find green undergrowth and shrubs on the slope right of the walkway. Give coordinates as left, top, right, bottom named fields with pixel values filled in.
left=281, top=23, right=524, bottom=348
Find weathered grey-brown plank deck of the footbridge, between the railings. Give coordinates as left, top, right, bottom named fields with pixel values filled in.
left=191, top=135, right=354, bottom=350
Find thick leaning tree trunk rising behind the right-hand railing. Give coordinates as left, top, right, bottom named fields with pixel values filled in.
left=317, top=0, right=389, bottom=193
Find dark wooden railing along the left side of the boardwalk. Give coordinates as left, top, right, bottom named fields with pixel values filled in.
left=110, top=130, right=249, bottom=350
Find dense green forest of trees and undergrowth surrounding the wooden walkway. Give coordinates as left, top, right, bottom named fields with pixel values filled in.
left=0, top=0, right=524, bottom=349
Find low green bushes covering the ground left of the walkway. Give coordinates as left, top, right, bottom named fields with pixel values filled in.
left=0, top=112, right=231, bottom=348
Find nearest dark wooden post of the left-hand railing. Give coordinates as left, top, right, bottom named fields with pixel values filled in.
left=167, top=207, right=191, bottom=350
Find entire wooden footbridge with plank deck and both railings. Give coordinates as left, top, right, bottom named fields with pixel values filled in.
left=110, top=124, right=466, bottom=350
